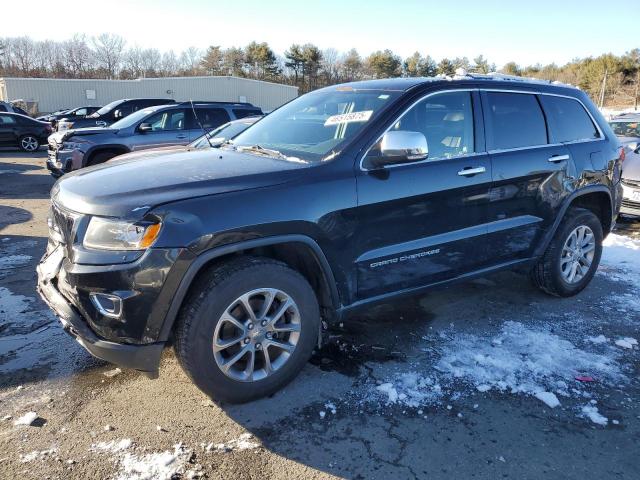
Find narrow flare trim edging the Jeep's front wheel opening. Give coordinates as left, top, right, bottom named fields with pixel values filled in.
left=158, top=234, right=340, bottom=342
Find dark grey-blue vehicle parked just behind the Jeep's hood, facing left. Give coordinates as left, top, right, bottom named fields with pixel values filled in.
left=47, top=102, right=261, bottom=177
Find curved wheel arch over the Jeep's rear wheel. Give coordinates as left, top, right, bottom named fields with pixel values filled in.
left=535, top=185, right=613, bottom=256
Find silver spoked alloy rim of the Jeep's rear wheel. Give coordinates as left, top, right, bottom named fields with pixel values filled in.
left=560, top=225, right=596, bottom=284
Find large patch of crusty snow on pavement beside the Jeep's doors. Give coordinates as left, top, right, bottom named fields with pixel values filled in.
left=369, top=321, right=627, bottom=408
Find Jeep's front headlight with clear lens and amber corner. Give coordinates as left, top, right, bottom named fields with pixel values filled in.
left=82, top=217, right=162, bottom=250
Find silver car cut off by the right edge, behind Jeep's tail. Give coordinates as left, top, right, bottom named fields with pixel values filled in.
left=609, top=113, right=640, bottom=216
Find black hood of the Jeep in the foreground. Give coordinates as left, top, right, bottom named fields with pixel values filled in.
left=51, top=149, right=308, bottom=219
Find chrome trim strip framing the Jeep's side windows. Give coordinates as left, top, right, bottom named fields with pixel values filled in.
left=359, top=87, right=607, bottom=172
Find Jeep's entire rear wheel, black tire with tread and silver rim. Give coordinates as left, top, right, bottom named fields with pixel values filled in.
left=531, top=208, right=603, bottom=297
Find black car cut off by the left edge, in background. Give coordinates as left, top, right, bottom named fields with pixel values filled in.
left=0, top=112, right=53, bottom=152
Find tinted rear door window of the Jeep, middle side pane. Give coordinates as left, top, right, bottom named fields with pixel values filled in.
left=486, top=91, right=547, bottom=150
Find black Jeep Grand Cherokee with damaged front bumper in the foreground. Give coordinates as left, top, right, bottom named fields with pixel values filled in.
left=38, top=76, right=622, bottom=402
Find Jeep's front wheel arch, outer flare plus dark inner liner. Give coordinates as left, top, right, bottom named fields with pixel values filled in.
left=158, top=235, right=341, bottom=342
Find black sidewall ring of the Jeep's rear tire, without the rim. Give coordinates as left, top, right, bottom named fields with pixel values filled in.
left=550, top=210, right=603, bottom=296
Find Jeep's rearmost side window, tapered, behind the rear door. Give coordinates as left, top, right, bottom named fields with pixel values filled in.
left=539, top=95, right=600, bottom=143
